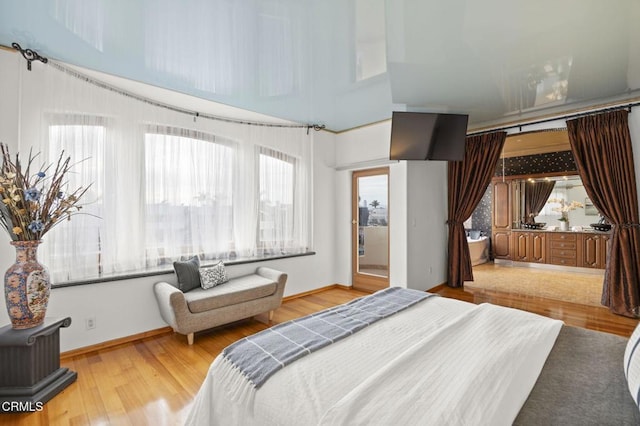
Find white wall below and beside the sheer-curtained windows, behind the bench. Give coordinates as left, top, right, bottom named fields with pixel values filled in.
left=0, top=52, right=339, bottom=351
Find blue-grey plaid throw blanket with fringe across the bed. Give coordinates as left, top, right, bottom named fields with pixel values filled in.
left=222, top=287, right=435, bottom=389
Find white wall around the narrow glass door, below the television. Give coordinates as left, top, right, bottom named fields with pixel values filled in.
left=336, top=121, right=447, bottom=290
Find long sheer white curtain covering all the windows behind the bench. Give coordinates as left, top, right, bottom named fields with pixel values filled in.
left=8, top=52, right=313, bottom=282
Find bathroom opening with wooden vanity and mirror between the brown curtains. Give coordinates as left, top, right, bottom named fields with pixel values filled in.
left=480, top=129, right=608, bottom=306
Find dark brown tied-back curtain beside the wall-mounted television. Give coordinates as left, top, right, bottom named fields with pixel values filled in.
left=447, top=132, right=507, bottom=287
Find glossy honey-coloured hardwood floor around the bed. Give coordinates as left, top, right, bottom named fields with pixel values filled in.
left=6, top=280, right=637, bottom=426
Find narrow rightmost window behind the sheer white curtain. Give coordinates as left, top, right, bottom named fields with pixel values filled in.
left=258, top=147, right=296, bottom=254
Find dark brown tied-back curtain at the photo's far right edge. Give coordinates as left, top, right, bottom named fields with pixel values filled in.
left=567, top=110, right=640, bottom=317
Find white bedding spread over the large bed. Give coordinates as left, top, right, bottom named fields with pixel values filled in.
left=187, top=297, right=561, bottom=425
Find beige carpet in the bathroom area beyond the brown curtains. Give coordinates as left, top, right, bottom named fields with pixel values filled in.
left=464, top=263, right=604, bottom=306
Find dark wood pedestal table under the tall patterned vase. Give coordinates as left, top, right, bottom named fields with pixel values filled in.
left=0, top=318, right=78, bottom=413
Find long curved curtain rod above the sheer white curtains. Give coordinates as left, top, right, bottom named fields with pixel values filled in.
left=0, top=43, right=325, bottom=134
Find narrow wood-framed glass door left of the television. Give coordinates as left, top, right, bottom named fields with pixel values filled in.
left=351, top=167, right=390, bottom=292
